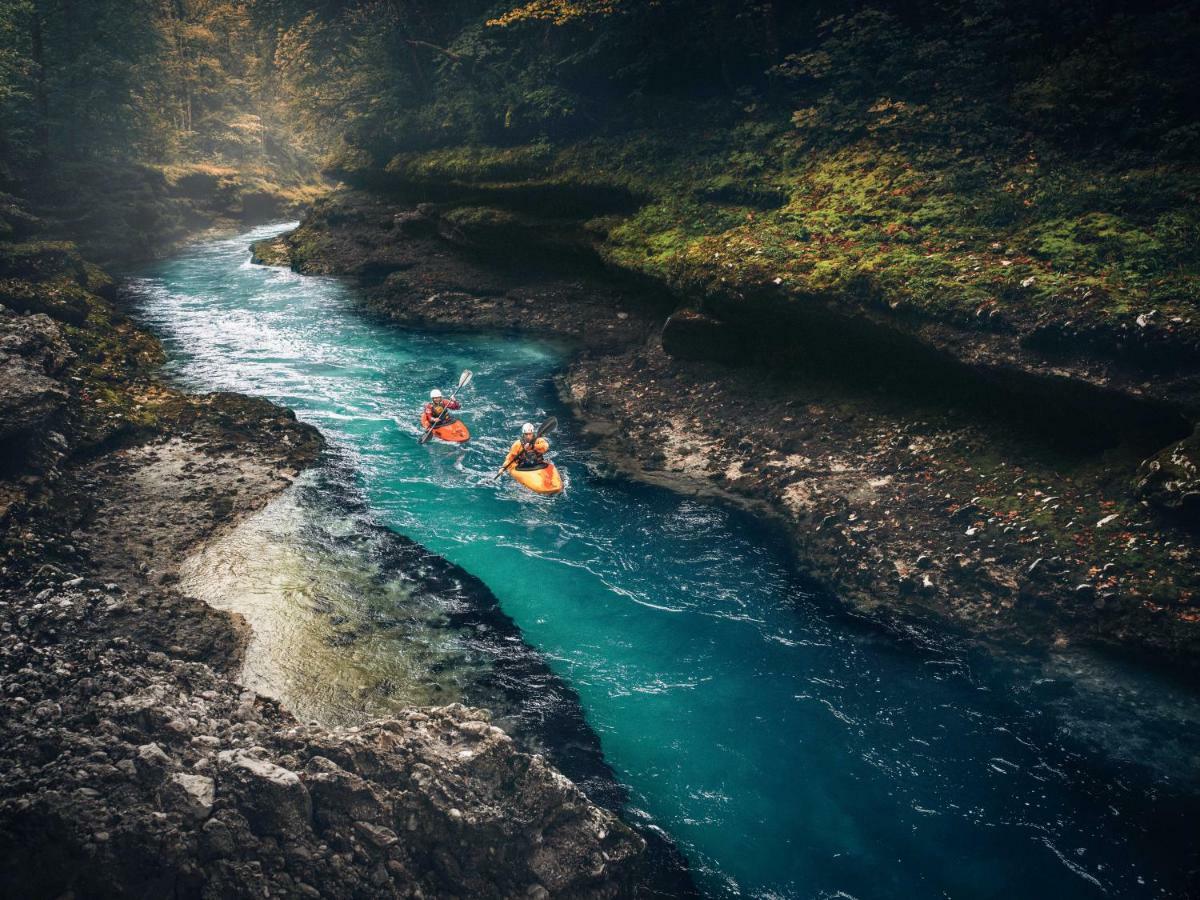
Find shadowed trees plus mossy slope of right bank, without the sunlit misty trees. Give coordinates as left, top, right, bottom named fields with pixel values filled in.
left=236, top=0, right=1200, bottom=355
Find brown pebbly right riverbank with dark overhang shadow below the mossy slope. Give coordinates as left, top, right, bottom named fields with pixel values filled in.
left=265, top=193, right=1200, bottom=668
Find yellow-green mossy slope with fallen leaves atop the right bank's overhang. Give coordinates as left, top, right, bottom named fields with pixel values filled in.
left=362, top=115, right=1200, bottom=360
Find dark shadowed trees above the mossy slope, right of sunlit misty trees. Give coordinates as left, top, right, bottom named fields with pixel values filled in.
left=234, top=0, right=1200, bottom=155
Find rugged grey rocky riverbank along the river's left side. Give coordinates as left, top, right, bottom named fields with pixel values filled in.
left=0, top=199, right=644, bottom=898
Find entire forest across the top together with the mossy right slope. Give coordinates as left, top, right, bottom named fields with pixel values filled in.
left=0, top=0, right=1200, bottom=328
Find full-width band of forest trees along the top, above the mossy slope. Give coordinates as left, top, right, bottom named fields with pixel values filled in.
left=0, top=0, right=1200, bottom=180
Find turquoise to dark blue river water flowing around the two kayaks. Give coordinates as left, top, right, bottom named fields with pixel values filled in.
left=124, top=229, right=1200, bottom=898
